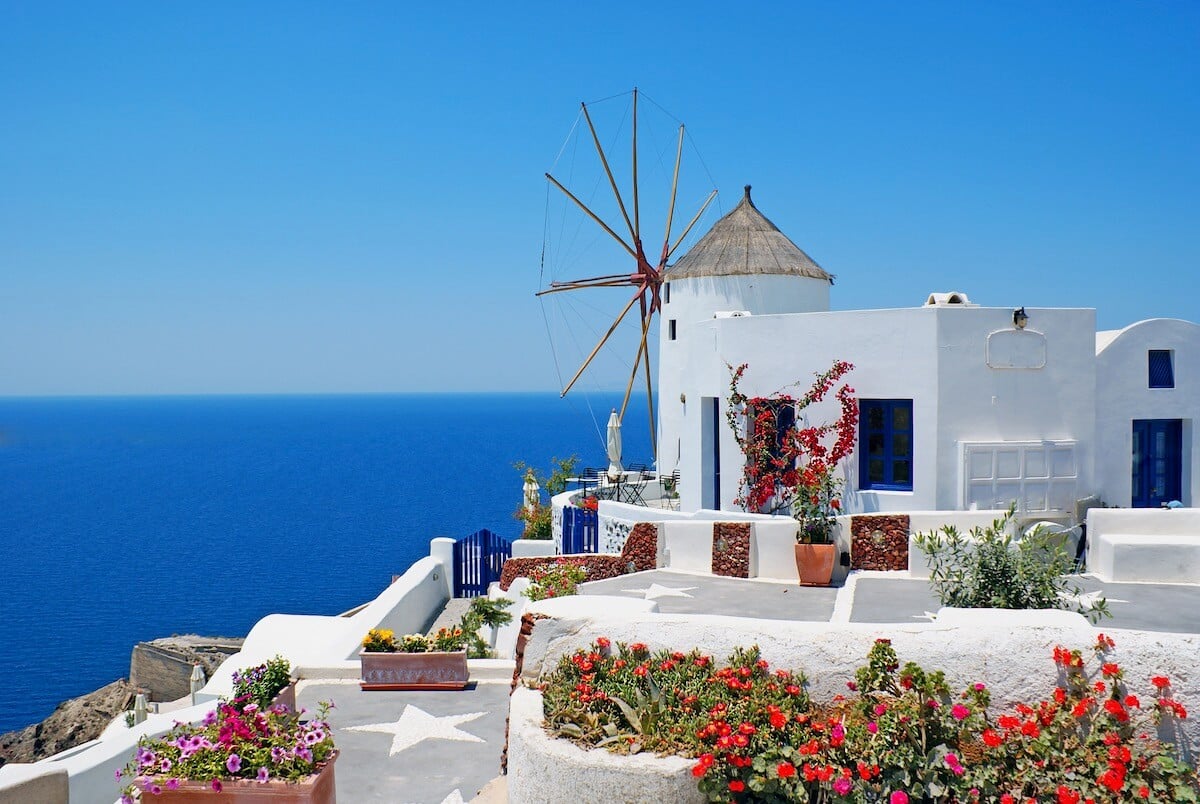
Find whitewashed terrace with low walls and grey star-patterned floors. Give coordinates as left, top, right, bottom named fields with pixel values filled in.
left=0, top=501, right=1200, bottom=804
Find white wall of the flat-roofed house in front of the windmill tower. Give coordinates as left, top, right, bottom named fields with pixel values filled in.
left=661, top=306, right=1096, bottom=520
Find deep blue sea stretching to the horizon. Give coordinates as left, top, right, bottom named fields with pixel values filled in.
left=0, top=394, right=650, bottom=732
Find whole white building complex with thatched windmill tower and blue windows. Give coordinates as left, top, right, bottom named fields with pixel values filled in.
left=659, top=187, right=1200, bottom=518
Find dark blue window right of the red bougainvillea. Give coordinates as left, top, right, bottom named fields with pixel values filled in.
left=858, top=400, right=912, bottom=491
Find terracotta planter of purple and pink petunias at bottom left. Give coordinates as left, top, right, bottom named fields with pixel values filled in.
left=118, top=701, right=337, bottom=804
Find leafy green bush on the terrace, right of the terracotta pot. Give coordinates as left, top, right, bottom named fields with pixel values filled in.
left=914, top=508, right=1111, bottom=623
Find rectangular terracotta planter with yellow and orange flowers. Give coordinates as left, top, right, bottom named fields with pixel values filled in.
left=359, top=598, right=512, bottom=690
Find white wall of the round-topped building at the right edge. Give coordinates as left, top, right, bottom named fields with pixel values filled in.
left=1096, top=318, right=1200, bottom=505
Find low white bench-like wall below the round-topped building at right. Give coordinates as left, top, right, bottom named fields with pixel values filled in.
left=1087, top=508, right=1200, bottom=583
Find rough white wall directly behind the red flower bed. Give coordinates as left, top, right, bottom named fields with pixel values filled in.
left=520, top=608, right=1200, bottom=763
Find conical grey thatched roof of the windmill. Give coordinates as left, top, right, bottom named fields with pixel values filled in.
left=662, top=185, right=833, bottom=284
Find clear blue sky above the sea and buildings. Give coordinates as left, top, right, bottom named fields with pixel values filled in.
left=0, top=0, right=1200, bottom=395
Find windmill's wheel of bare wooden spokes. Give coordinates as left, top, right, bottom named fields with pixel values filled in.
left=536, top=88, right=716, bottom=465
